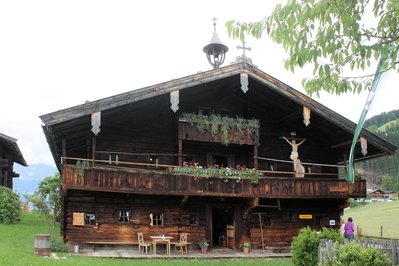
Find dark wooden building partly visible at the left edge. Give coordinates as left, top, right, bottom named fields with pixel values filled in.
left=0, top=133, right=28, bottom=189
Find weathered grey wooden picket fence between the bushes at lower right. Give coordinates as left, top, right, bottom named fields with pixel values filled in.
left=318, top=238, right=399, bottom=265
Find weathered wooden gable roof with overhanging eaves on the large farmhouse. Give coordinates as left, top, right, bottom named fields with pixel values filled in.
left=40, top=63, right=397, bottom=168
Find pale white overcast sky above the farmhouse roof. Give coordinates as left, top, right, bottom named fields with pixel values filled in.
left=0, top=0, right=399, bottom=165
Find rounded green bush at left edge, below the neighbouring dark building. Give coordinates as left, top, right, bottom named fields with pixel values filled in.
left=0, top=186, right=21, bottom=224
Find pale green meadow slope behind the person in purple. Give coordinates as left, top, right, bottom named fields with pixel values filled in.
left=344, top=200, right=399, bottom=238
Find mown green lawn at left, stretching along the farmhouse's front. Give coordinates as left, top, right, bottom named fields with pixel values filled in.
left=0, top=213, right=293, bottom=266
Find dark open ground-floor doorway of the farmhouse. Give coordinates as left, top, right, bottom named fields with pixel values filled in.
left=212, top=207, right=234, bottom=247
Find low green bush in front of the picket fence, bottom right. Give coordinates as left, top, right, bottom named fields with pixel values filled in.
left=327, top=242, right=391, bottom=266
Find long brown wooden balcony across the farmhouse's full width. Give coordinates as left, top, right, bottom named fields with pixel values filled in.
left=62, top=165, right=366, bottom=198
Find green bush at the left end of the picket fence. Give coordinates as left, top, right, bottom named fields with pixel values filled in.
left=291, top=227, right=343, bottom=266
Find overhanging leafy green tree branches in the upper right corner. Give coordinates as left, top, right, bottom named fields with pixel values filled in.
left=226, top=0, right=399, bottom=95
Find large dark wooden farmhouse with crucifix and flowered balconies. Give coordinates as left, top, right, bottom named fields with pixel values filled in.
left=41, top=62, right=396, bottom=252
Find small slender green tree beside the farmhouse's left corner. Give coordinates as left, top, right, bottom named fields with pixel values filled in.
left=25, top=174, right=61, bottom=239
